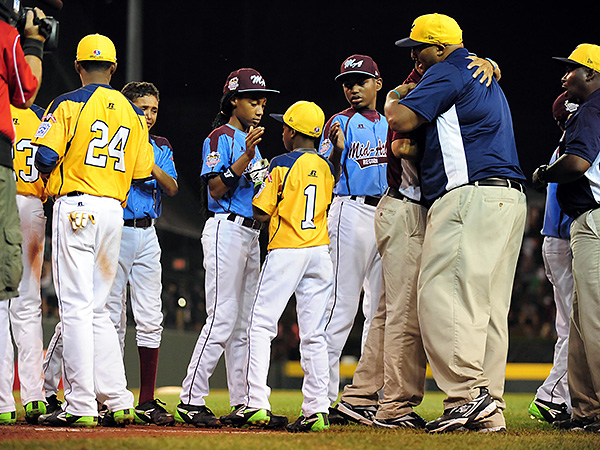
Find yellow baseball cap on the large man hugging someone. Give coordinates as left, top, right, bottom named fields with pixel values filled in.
left=396, top=13, right=462, bottom=47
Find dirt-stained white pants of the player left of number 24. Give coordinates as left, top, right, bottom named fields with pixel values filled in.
left=9, top=195, right=46, bottom=405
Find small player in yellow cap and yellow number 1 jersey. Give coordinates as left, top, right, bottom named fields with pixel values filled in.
left=221, top=101, right=334, bottom=432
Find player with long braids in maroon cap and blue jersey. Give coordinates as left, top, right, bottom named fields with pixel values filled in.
left=175, top=68, right=278, bottom=427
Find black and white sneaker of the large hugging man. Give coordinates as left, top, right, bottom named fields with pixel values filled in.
left=425, top=388, right=497, bottom=433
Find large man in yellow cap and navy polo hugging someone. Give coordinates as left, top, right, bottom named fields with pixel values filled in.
left=385, top=14, right=526, bottom=432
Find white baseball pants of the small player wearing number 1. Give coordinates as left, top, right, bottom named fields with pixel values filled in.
left=244, top=245, right=333, bottom=417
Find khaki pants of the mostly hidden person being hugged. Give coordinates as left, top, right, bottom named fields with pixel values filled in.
left=342, top=196, right=427, bottom=420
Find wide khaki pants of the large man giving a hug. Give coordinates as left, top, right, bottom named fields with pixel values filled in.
left=418, top=185, right=527, bottom=409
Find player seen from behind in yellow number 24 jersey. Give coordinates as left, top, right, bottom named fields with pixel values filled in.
left=33, top=34, right=154, bottom=427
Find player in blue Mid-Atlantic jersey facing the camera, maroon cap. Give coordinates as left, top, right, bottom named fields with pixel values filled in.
left=320, top=55, right=388, bottom=410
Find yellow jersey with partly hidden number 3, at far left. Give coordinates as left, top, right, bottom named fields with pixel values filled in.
left=10, top=105, right=46, bottom=202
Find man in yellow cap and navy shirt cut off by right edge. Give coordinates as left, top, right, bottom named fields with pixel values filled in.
left=533, top=44, right=600, bottom=432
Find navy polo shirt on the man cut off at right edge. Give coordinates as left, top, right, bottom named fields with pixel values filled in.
left=556, top=89, right=600, bottom=218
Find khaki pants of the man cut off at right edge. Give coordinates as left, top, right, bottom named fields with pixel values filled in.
left=567, top=209, right=600, bottom=420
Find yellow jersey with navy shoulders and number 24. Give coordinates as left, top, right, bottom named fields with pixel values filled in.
left=34, top=84, right=154, bottom=202
